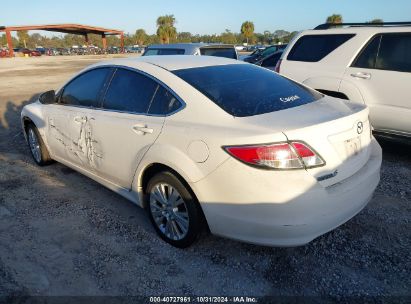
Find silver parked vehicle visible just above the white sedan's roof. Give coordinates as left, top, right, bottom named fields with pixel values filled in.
left=143, top=43, right=238, bottom=59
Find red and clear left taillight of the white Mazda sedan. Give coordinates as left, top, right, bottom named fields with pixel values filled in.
left=224, top=142, right=325, bottom=169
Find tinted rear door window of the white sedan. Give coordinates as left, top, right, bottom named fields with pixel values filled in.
left=103, top=69, right=157, bottom=113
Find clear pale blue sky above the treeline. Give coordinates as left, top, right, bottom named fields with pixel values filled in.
left=0, top=0, right=411, bottom=34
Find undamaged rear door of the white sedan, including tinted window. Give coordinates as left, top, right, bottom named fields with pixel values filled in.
left=91, top=68, right=180, bottom=189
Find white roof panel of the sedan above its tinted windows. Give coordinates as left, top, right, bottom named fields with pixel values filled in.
left=94, top=55, right=247, bottom=71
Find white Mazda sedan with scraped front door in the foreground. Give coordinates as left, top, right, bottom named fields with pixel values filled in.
left=21, top=56, right=381, bottom=247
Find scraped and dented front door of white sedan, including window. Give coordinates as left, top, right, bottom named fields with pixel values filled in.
left=48, top=68, right=111, bottom=166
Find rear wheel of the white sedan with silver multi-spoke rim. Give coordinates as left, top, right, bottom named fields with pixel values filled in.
left=145, top=172, right=204, bottom=248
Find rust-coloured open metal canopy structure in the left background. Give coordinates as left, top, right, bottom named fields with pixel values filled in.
left=0, top=24, right=124, bottom=57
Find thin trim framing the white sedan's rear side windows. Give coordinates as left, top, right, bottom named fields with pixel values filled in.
left=99, top=65, right=186, bottom=117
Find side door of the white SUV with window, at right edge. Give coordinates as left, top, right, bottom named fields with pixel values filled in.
left=344, top=33, right=411, bottom=134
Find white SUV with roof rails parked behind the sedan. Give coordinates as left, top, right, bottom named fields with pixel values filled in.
left=276, top=22, right=411, bottom=137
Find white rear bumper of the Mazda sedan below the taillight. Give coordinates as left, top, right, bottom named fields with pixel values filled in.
left=192, top=139, right=382, bottom=246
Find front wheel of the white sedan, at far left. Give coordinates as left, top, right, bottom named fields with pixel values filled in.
left=26, top=123, right=52, bottom=166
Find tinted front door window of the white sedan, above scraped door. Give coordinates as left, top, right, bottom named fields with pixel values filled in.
left=60, top=68, right=111, bottom=108
